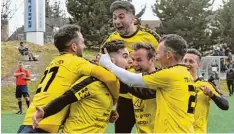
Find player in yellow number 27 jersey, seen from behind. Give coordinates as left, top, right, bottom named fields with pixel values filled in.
left=18, top=25, right=119, bottom=133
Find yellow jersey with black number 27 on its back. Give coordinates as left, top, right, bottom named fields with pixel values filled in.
left=23, top=54, right=96, bottom=132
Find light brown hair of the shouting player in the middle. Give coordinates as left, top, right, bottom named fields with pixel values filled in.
left=132, top=42, right=156, bottom=59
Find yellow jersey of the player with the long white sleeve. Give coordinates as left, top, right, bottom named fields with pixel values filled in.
left=143, top=65, right=196, bottom=133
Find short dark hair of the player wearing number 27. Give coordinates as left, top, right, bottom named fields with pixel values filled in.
left=54, top=24, right=80, bottom=52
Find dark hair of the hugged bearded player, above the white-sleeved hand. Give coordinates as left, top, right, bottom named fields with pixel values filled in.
left=101, top=40, right=125, bottom=54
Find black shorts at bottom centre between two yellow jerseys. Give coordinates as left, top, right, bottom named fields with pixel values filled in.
left=115, top=97, right=136, bottom=133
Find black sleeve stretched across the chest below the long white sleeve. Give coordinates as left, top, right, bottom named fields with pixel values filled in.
left=120, top=82, right=156, bottom=100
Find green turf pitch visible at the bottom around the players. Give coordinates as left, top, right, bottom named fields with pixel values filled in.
left=1, top=96, right=234, bottom=133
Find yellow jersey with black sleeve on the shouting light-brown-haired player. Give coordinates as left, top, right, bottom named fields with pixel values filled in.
left=120, top=71, right=156, bottom=133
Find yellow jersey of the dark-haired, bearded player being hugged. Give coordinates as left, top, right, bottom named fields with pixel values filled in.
left=63, top=76, right=113, bottom=133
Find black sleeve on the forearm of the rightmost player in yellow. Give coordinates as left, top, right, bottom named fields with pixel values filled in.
left=211, top=95, right=229, bottom=110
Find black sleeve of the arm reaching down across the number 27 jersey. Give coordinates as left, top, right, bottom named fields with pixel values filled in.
left=43, top=90, right=77, bottom=118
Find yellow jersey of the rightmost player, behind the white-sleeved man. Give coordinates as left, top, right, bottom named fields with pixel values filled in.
left=194, top=79, right=220, bottom=133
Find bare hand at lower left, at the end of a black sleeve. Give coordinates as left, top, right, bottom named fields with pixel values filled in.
left=32, top=107, right=44, bottom=129
